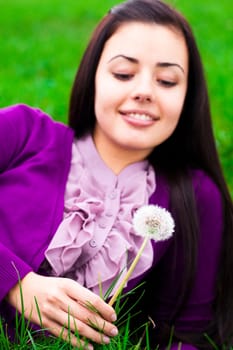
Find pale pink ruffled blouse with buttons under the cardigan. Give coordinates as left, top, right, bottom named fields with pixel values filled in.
left=45, top=135, right=155, bottom=294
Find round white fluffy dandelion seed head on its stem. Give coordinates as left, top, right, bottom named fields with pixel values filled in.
left=133, top=204, right=175, bottom=241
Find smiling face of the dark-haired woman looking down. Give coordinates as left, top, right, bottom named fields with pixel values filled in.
left=94, top=22, right=188, bottom=170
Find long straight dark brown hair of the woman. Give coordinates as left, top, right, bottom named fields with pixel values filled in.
left=69, top=0, right=233, bottom=344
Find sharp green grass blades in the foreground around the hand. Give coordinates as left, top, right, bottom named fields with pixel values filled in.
left=0, top=285, right=223, bottom=350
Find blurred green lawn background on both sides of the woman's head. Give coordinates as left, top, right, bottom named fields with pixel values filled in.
left=0, top=0, right=233, bottom=194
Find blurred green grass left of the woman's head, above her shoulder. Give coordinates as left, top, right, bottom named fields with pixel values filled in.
left=0, top=0, right=118, bottom=121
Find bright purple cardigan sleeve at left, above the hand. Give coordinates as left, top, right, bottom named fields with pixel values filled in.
left=0, top=105, right=73, bottom=301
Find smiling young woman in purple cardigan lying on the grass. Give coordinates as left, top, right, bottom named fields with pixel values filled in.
left=0, top=0, right=233, bottom=349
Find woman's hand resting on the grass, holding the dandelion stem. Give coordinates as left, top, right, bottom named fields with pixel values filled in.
left=7, top=272, right=117, bottom=349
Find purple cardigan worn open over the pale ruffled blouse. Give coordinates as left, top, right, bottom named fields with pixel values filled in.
left=0, top=105, right=222, bottom=331
